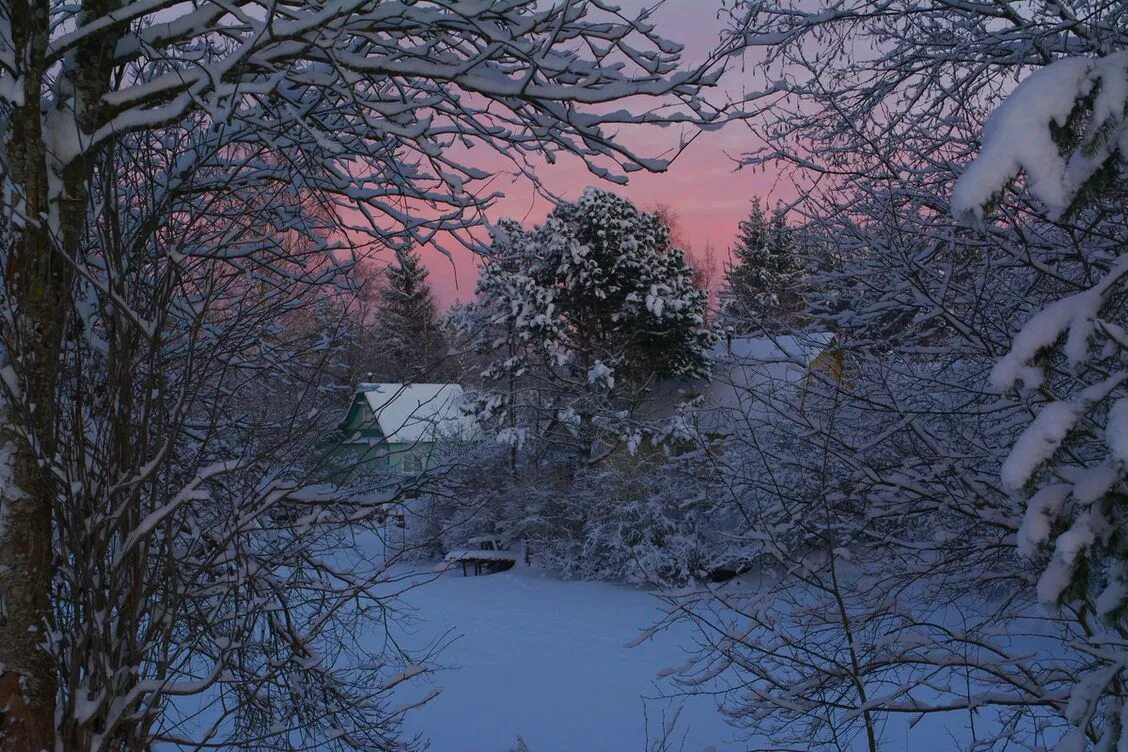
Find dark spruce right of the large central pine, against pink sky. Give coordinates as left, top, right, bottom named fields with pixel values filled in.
left=721, top=198, right=804, bottom=331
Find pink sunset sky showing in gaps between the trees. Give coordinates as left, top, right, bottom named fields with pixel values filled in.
left=422, top=0, right=793, bottom=308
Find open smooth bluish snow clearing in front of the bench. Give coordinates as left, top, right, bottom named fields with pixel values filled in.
left=388, top=568, right=733, bottom=752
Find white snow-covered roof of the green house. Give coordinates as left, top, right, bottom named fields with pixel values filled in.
left=358, top=383, right=473, bottom=444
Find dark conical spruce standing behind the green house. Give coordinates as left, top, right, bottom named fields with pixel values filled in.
left=369, top=248, right=450, bottom=383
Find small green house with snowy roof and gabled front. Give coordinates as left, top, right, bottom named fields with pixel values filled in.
left=332, top=383, right=474, bottom=480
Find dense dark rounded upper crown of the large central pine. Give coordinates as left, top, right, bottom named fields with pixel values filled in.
left=478, top=188, right=711, bottom=384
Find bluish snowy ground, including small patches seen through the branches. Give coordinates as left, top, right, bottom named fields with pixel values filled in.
left=164, top=533, right=1015, bottom=752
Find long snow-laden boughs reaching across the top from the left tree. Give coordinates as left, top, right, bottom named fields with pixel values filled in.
left=28, top=0, right=735, bottom=182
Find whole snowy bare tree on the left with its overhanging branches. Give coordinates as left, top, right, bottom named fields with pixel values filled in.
left=0, top=0, right=739, bottom=750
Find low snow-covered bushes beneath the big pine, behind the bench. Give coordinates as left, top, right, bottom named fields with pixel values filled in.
left=425, top=441, right=720, bottom=586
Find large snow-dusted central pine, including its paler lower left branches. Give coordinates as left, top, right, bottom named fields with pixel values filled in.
left=465, top=188, right=713, bottom=462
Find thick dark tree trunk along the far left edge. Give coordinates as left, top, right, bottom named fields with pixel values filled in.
left=0, top=0, right=60, bottom=752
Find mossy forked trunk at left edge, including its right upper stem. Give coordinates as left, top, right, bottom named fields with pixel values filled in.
left=0, top=0, right=117, bottom=752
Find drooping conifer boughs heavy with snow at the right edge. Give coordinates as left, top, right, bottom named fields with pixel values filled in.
left=952, top=52, right=1128, bottom=752
